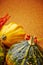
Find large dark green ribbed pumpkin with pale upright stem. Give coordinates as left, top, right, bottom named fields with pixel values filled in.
left=6, top=37, right=43, bottom=65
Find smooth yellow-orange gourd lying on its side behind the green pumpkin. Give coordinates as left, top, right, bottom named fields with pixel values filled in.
left=0, top=22, right=25, bottom=47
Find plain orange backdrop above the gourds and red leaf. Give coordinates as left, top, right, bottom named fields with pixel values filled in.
left=0, top=0, right=43, bottom=37
